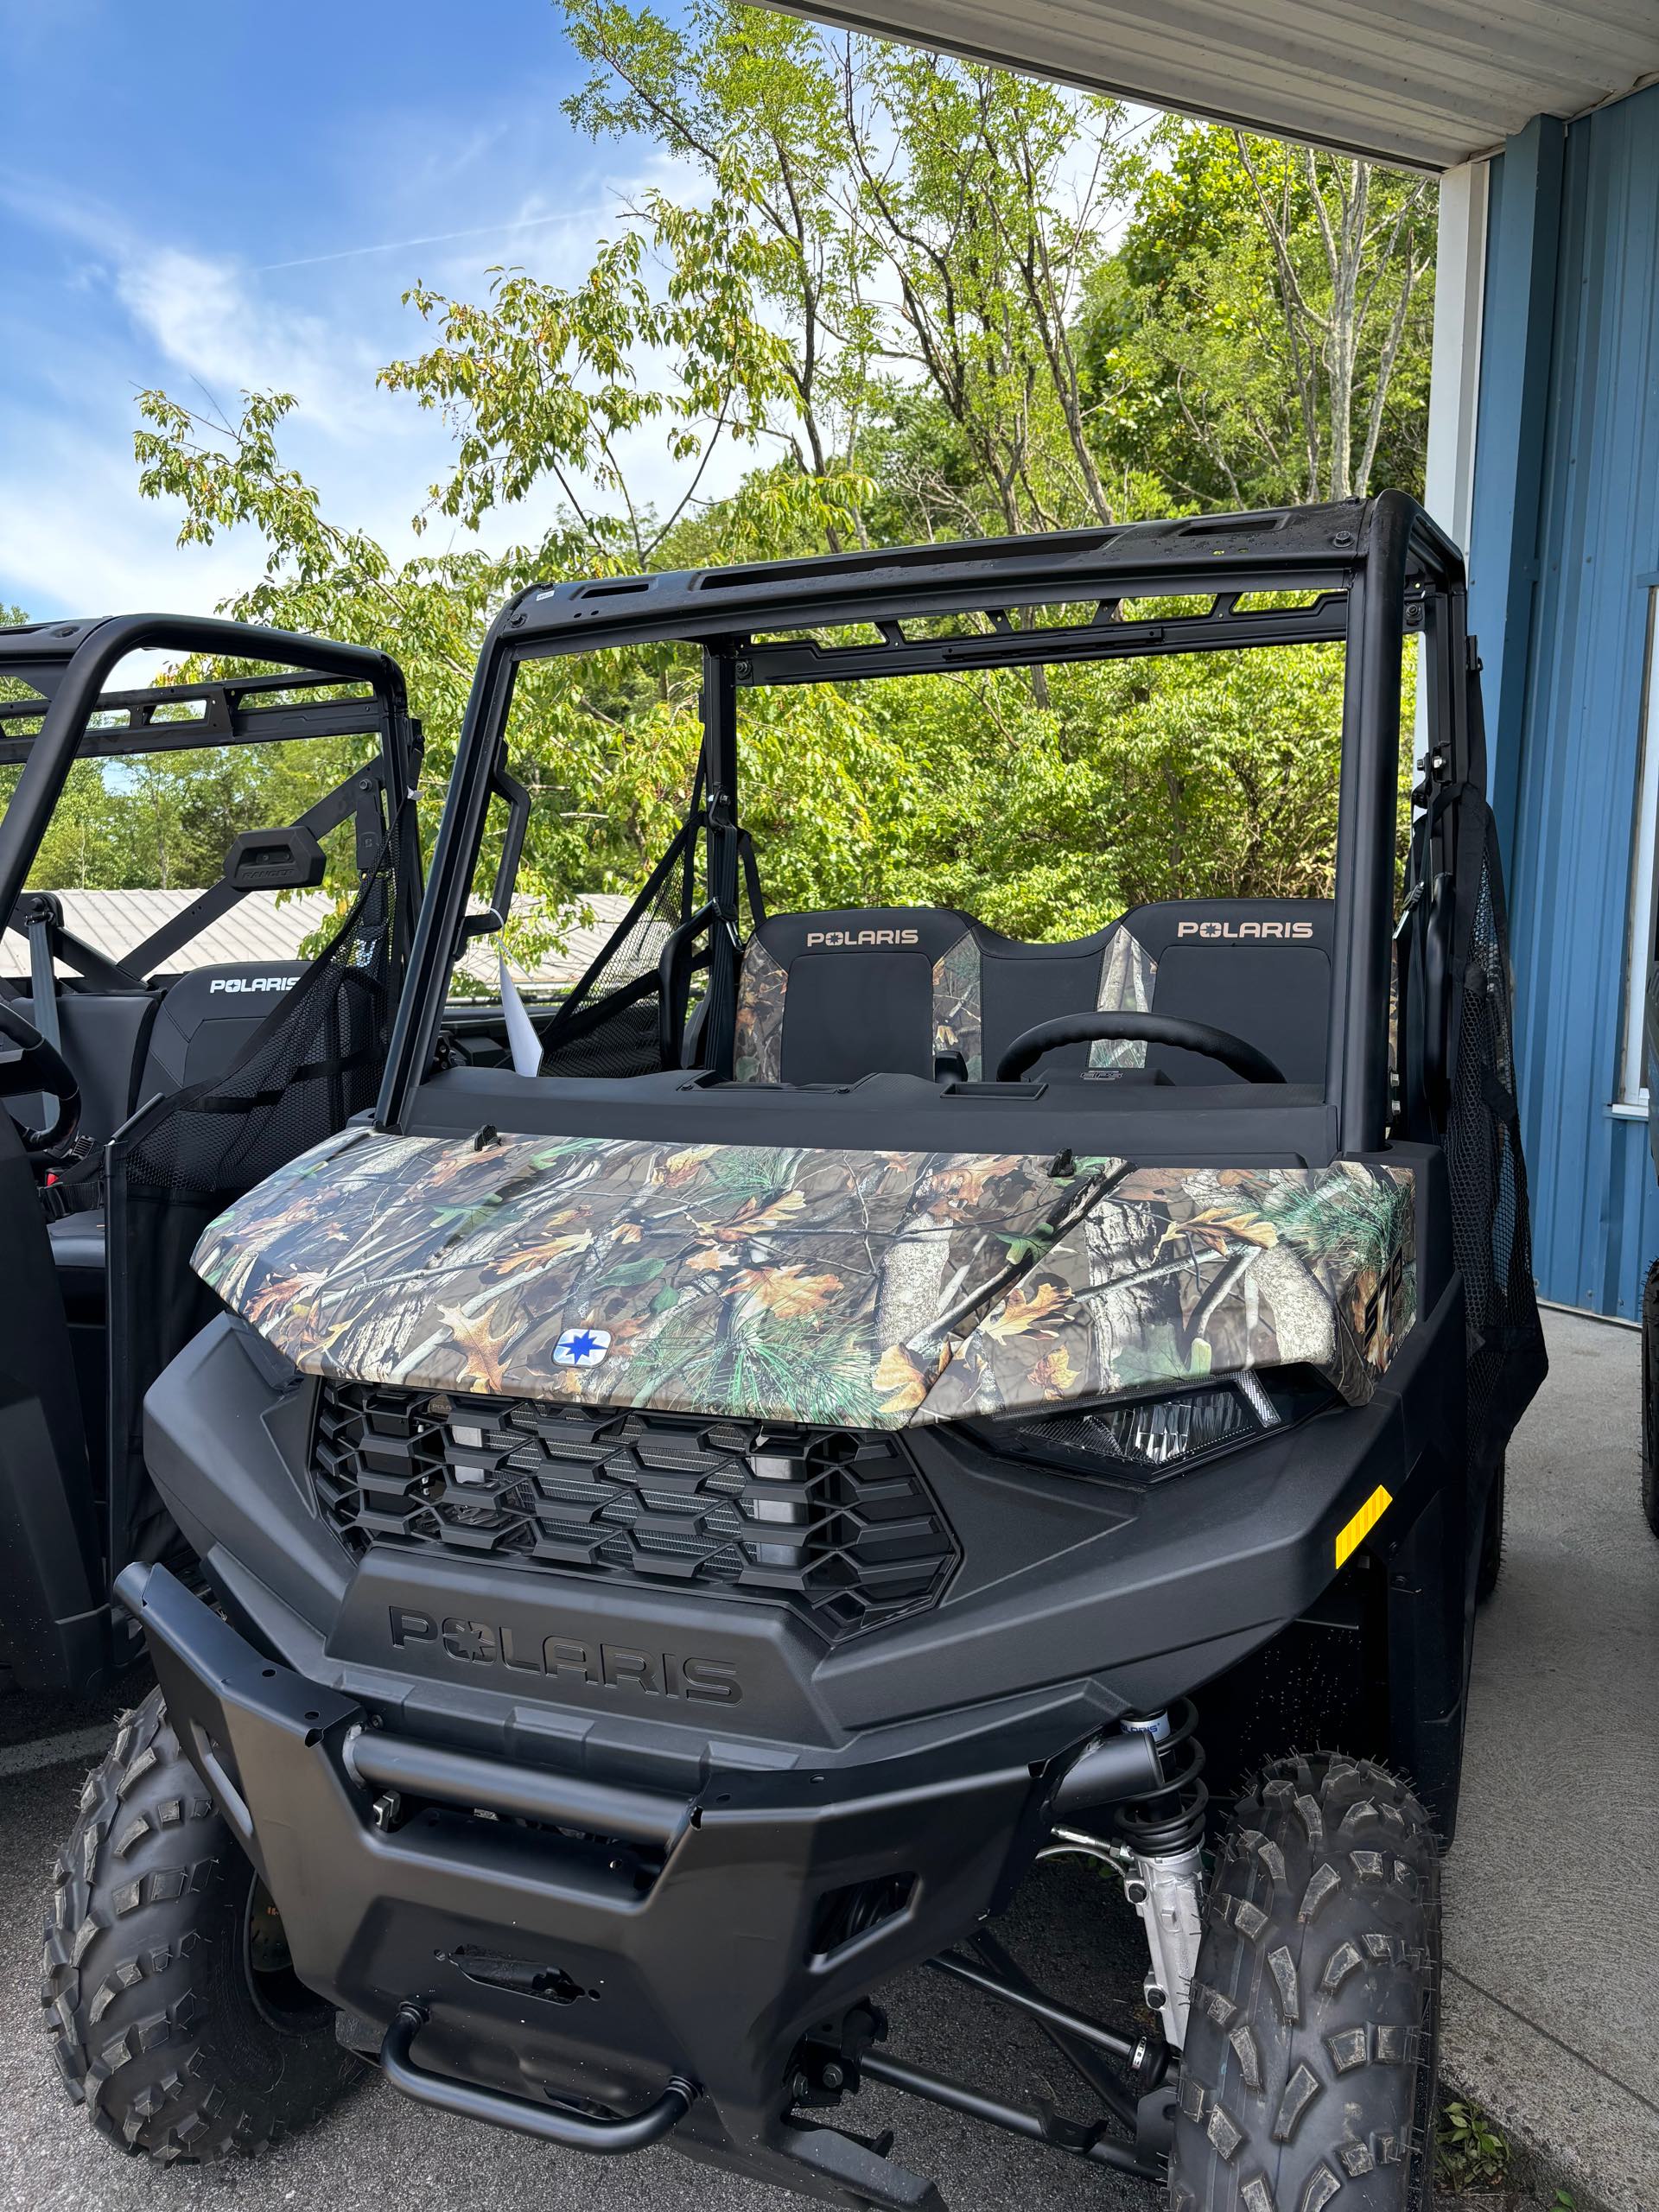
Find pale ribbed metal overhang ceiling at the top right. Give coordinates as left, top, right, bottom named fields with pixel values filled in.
left=774, top=0, right=1659, bottom=168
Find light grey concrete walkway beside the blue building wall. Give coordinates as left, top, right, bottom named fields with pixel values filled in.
left=1442, top=1314, right=1659, bottom=2212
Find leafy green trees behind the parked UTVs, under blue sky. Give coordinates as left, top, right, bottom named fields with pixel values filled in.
left=111, top=26, right=1429, bottom=936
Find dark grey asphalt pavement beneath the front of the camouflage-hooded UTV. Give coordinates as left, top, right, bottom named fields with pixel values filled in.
left=0, top=1765, right=1154, bottom=2212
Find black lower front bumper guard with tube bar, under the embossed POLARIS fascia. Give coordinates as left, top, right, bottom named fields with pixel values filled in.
left=119, top=1566, right=1042, bottom=2205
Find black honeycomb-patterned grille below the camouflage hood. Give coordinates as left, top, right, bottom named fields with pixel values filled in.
left=312, top=1382, right=957, bottom=1639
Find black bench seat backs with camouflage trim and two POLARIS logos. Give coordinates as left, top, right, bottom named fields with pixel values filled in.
left=736, top=898, right=1332, bottom=1086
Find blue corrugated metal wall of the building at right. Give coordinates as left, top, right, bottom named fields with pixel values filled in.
left=1473, top=88, right=1659, bottom=1319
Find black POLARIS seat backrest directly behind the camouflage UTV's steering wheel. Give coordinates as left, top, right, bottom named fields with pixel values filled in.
left=1117, top=898, right=1336, bottom=1084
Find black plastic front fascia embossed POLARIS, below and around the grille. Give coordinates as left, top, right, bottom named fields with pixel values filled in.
left=143, top=1294, right=1465, bottom=1760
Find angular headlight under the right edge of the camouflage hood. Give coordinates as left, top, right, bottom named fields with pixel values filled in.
left=995, top=1370, right=1332, bottom=1482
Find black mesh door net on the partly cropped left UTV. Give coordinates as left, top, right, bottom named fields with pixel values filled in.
left=108, top=836, right=407, bottom=1571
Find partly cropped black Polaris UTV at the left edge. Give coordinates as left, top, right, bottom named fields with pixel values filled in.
left=0, top=615, right=420, bottom=1697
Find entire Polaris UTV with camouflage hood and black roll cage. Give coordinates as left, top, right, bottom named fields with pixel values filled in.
left=47, top=493, right=1541, bottom=2212
